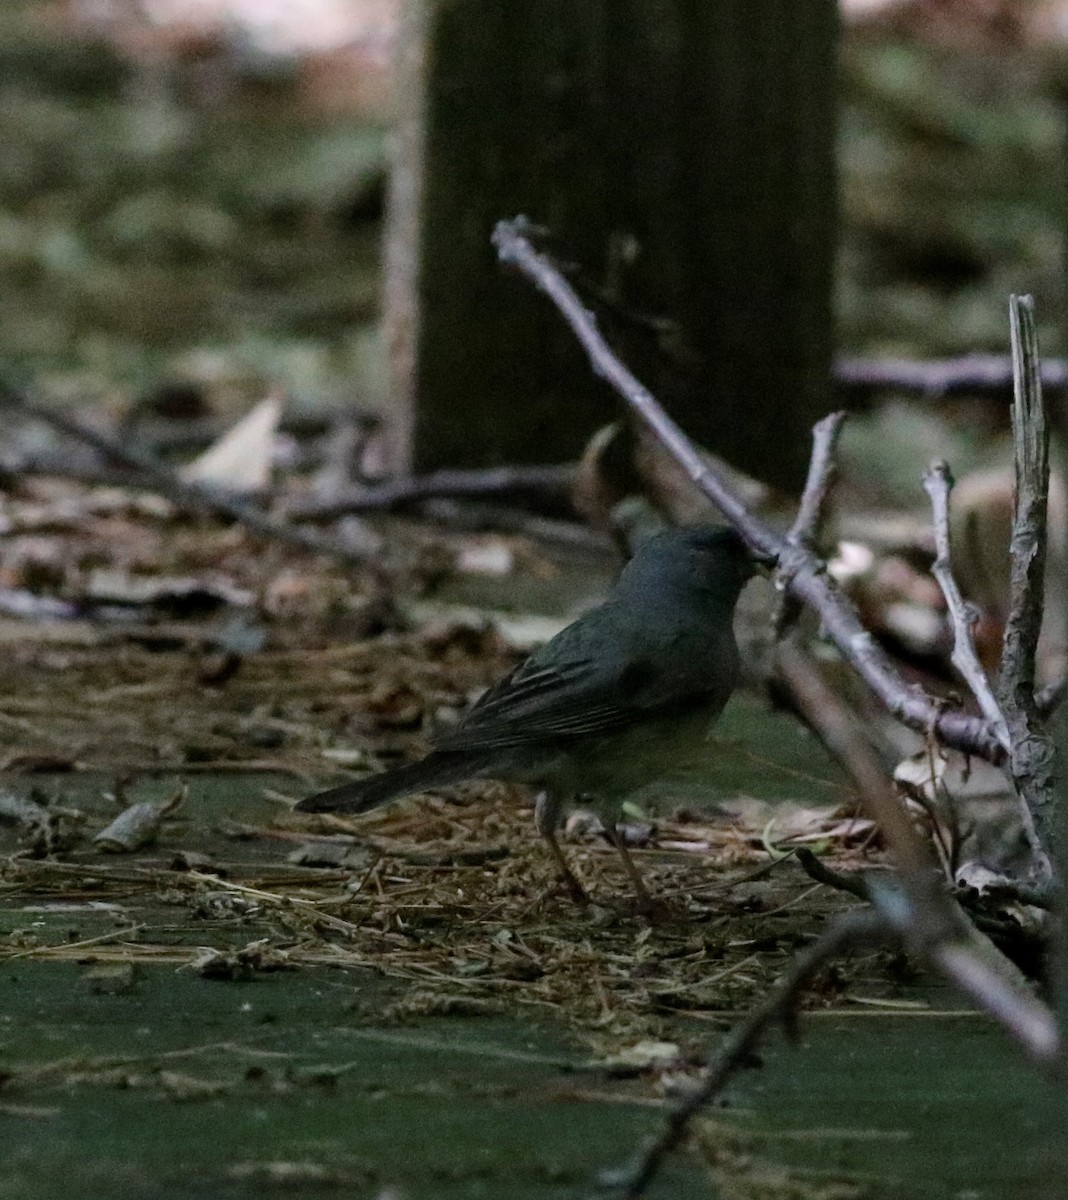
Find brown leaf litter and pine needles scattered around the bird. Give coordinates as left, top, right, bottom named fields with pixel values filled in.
left=0, top=468, right=892, bottom=1060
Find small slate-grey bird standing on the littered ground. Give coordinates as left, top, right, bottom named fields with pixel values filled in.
left=296, top=526, right=756, bottom=907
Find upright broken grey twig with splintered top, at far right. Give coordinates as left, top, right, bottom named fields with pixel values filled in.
left=998, top=296, right=1056, bottom=877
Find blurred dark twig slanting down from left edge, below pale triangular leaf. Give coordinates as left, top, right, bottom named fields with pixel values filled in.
left=0, top=380, right=384, bottom=569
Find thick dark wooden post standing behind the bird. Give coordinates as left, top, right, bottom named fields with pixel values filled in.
left=386, top=0, right=836, bottom=487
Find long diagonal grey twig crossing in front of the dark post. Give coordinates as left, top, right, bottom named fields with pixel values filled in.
left=493, top=218, right=1004, bottom=762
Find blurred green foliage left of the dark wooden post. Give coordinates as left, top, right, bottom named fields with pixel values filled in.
left=0, top=2, right=384, bottom=408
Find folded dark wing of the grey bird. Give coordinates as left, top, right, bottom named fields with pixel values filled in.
left=434, top=610, right=712, bottom=750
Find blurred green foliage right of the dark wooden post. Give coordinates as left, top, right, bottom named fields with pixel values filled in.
left=839, top=36, right=1066, bottom=355
